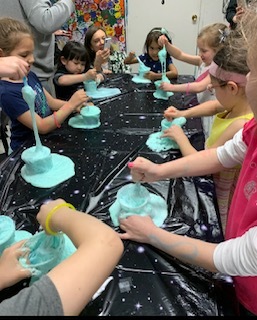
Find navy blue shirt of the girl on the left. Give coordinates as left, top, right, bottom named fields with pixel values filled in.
left=0, top=71, right=52, bottom=151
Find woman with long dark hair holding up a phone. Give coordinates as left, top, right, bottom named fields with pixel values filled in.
left=84, top=26, right=111, bottom=74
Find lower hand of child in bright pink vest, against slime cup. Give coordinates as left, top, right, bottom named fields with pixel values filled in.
left=119, top=215, right=157, bottom=243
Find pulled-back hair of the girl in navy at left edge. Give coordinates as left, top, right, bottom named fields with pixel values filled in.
left=0, top=17, right=33, bottom=55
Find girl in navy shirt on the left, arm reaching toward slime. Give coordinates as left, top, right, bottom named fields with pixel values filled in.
left=0, top=18, right=88, bottom=152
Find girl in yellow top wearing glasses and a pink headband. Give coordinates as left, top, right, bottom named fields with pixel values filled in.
left=163, top=32, right=253, bottom=231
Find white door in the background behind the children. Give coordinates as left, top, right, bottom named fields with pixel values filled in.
left=126, top=0, right=224, bottom=75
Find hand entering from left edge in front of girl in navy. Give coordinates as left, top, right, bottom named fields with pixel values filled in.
left=0, top=56, right=29, bottom=80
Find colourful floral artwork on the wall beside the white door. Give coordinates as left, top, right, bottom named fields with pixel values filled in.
left=53, top=0, right=126, bottom=51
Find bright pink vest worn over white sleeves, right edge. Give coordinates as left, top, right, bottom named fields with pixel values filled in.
left=225, top=119, right=257, bottom=314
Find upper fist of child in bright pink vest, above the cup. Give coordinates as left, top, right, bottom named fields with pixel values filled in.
left=128, top=157, right=159, bottom=182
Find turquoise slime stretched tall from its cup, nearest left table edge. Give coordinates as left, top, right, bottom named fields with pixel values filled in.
left=21, top=77, right=75, bottom=188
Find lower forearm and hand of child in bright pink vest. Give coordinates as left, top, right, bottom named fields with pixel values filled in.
left=119, top=215, right=217, bottom=272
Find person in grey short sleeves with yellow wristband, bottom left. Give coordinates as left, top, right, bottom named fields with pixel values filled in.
left=0, top=199, right=124, bottom=316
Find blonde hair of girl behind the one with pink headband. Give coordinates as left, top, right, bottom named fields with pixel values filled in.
left=197, top=23, right=228, bottom=52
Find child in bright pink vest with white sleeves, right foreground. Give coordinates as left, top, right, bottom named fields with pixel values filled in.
left=119, top=2, right=257, bottom=316
